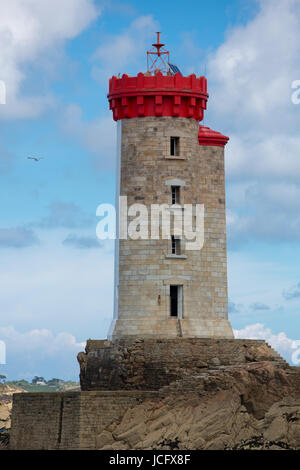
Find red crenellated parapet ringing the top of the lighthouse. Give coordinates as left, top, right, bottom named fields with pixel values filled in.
left=107, top=72, right=209, bottom=121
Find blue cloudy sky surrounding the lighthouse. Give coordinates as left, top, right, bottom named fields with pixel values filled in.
left=0, top=0, right=300, bottom=380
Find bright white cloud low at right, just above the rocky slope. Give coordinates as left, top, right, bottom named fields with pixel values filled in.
left=233, top=323, right=300, bottom=365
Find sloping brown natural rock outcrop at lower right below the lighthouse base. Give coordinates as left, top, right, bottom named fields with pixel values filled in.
left=96, top=362, right=300, bottom=450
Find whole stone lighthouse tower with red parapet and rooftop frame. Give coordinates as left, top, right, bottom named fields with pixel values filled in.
left=108, top=33, right=233, bottom=340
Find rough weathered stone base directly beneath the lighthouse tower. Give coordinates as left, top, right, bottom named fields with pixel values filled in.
left=78, top=338, right=288, bottom=391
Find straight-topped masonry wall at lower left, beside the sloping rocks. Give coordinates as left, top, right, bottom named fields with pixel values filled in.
left=10, top=391, right=157, bottom=450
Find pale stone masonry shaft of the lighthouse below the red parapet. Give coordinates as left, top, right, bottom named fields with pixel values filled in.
left=112, top=117, right=233, bottom=339
